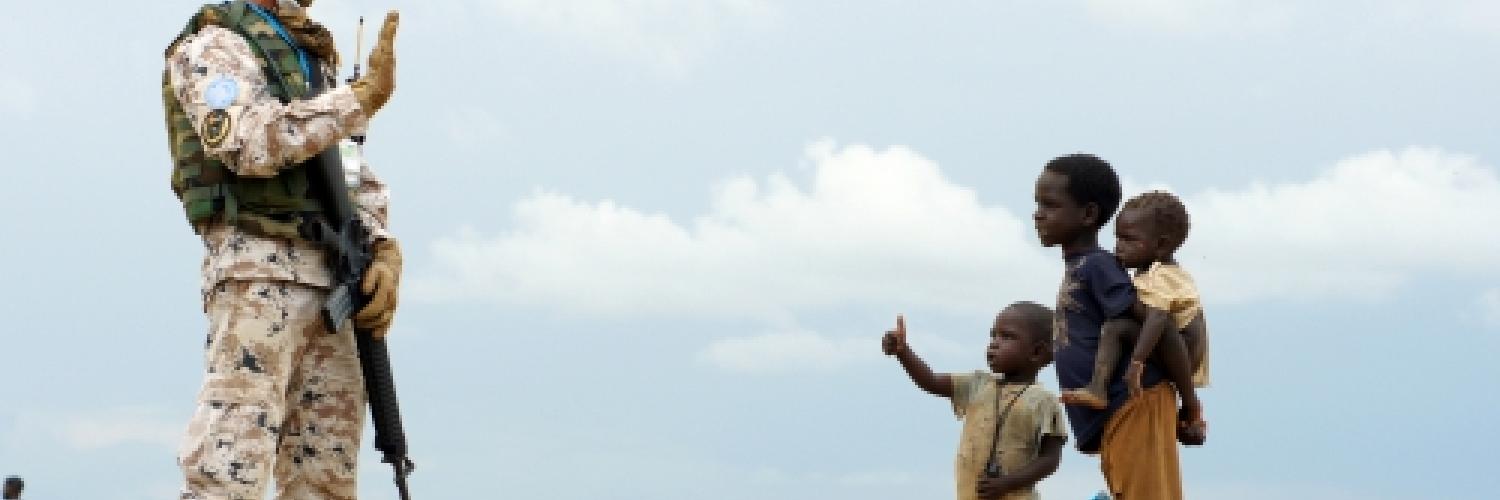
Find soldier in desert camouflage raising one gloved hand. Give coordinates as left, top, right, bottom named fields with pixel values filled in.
left=162, top=0, right=401, bottom=500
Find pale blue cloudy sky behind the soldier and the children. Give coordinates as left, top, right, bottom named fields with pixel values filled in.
left=0, top=0, right=1500, bottom=500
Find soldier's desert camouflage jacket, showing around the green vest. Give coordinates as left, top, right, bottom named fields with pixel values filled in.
left=167, top=14, right=390, bottom=294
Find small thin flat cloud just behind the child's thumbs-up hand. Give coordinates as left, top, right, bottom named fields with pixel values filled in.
left=698, top=330, right=980, bottom=374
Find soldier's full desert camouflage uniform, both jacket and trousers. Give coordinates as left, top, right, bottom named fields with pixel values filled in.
left=167, top=2, right=389, bottom=500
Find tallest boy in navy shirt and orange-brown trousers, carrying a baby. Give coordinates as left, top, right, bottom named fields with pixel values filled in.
left=1032, top=155, right=1182, bottom=500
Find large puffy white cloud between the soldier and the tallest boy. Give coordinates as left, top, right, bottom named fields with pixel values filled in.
left=411, top=141, right=1061, bottom=318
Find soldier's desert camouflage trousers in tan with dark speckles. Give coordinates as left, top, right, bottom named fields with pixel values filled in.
left=177, top=281, right=365, bottom=500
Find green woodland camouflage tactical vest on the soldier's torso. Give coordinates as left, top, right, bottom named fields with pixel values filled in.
left=162, top=0, right=323, bottom=237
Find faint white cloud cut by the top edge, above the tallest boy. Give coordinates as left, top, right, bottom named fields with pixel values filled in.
left=1085, top=0, right=1298, bottom=35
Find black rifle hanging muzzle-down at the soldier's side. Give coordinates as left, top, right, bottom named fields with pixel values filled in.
left=306, top=18, right=416, bottom=500
